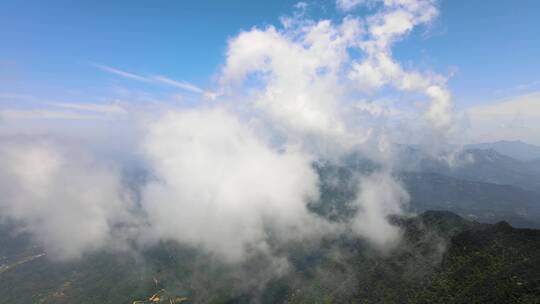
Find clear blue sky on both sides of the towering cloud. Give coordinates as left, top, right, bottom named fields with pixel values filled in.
left=0, top=0, right=540, bottom=107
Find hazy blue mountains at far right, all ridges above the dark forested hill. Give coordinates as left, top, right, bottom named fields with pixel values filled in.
left=401, top=142, right=540, bottom=227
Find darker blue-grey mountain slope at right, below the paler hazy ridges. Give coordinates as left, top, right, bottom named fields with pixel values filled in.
left=400, top=172, right=540, bottom=228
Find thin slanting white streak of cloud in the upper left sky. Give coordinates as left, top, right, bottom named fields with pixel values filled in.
left=95, top=64, right=217, bottom=99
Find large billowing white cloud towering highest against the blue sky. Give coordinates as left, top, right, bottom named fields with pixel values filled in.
left=221, top=0, right=454, bottom=144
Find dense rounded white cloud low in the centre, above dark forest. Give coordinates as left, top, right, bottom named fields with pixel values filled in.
left=143, top=109, right=332, bottom=262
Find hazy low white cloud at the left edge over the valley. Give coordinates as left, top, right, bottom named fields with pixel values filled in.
left=0, top=136, right=134, bottom=259
